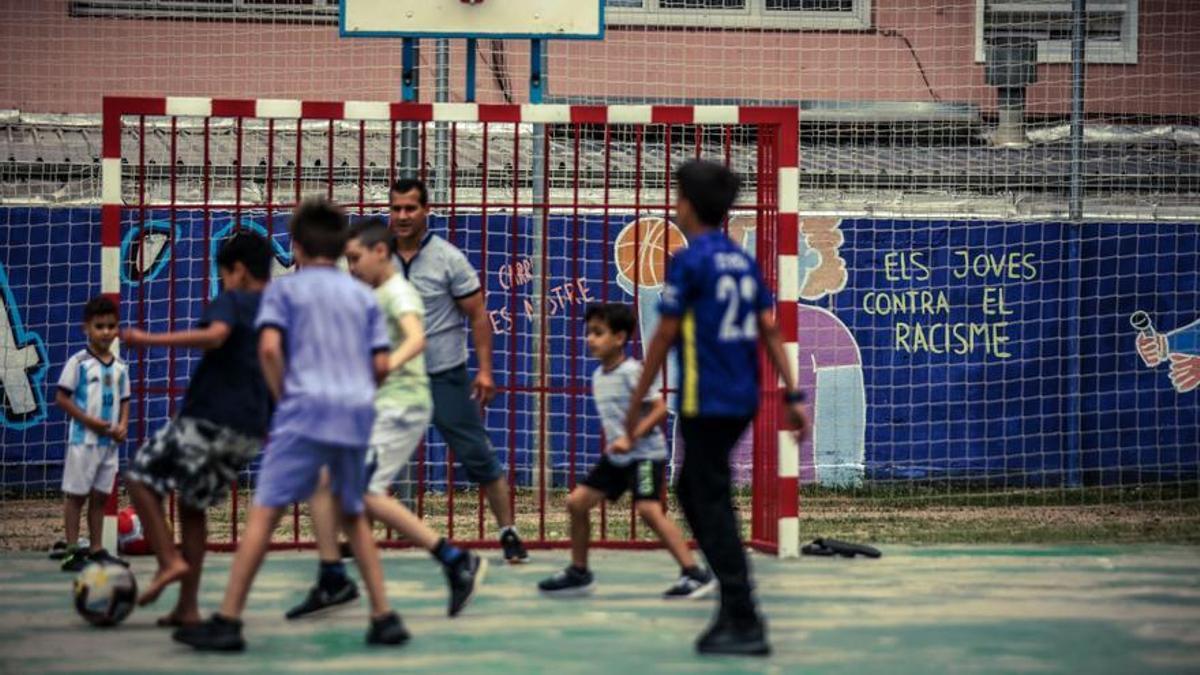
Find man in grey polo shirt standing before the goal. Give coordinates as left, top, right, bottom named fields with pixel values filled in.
left=388, top=179, right=529, bottom=563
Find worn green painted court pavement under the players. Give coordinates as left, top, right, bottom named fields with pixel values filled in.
left=0, top=546, right=1200, bottom=675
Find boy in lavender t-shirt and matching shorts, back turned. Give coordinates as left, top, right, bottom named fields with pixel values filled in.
left=174, top=199, right=409, bottom=651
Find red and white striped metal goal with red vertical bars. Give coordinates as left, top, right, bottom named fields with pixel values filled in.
left=101, top=96, right=799, bottom=556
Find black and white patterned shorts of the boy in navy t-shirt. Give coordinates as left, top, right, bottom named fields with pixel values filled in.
left=125, top=417, right=263, bottom=510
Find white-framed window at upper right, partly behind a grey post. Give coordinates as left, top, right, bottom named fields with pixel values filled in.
left=976, top=0, right=1138, bottom=64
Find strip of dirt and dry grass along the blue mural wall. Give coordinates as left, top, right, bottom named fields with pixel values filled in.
left=0, top=490, right=1200, bottom=551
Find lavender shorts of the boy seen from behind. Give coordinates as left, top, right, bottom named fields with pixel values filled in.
left=254, top=434, right=367, bottom=515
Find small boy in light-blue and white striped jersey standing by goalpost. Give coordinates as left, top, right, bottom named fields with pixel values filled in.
left=55, top=295, right=130, bottom=572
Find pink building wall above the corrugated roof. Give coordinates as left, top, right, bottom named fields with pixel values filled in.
left=0, top=0, right=1200, bottom=115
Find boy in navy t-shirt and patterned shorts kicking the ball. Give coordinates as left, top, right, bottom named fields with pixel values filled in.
left=121, top=232, right=271, bottom=626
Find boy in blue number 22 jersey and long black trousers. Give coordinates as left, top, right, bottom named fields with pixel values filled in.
left=625, top=161, right=808, bottom=656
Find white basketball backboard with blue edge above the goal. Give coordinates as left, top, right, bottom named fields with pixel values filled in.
left=338, top=0, right=604, bottom=40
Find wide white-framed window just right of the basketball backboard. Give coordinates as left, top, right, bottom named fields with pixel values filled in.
left=605, top=0, right=871, bottom=30
